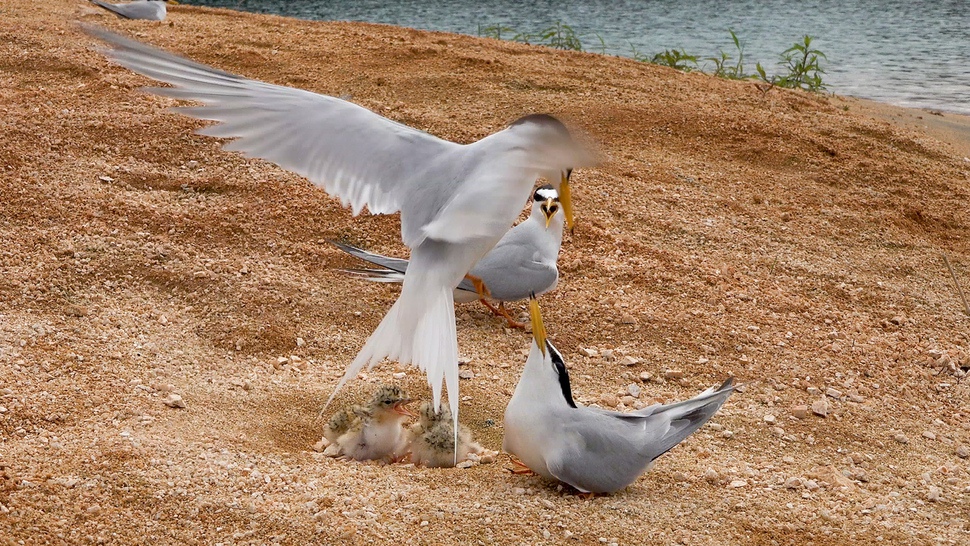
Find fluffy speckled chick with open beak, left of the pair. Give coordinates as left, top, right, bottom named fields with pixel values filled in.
left=324, top=385, right=414, bottom=462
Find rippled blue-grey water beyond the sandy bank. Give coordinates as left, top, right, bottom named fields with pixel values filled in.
left=187, top=0, right=970, bottom=114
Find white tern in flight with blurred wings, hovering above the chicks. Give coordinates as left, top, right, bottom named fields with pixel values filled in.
left=85, top=27, right=595, bottom=440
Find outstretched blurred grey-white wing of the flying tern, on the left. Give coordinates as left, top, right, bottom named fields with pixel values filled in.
left=85, top=27, right=461, bottom=215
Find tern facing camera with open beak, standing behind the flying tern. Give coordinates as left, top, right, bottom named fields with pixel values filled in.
left=333, top=184, right=565, bottom=328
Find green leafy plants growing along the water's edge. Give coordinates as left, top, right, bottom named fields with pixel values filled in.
left=478, top=21, right=828, bottom=92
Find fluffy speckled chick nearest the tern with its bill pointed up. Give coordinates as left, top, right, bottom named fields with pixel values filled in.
left=407, top=402, right=483, bottom=468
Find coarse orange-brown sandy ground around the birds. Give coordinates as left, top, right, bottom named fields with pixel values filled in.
left=0, top=0, right=970, bottom=545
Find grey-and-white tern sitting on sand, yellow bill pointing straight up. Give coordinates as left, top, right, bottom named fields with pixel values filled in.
left=502, top=298, right=734, bottom=493
